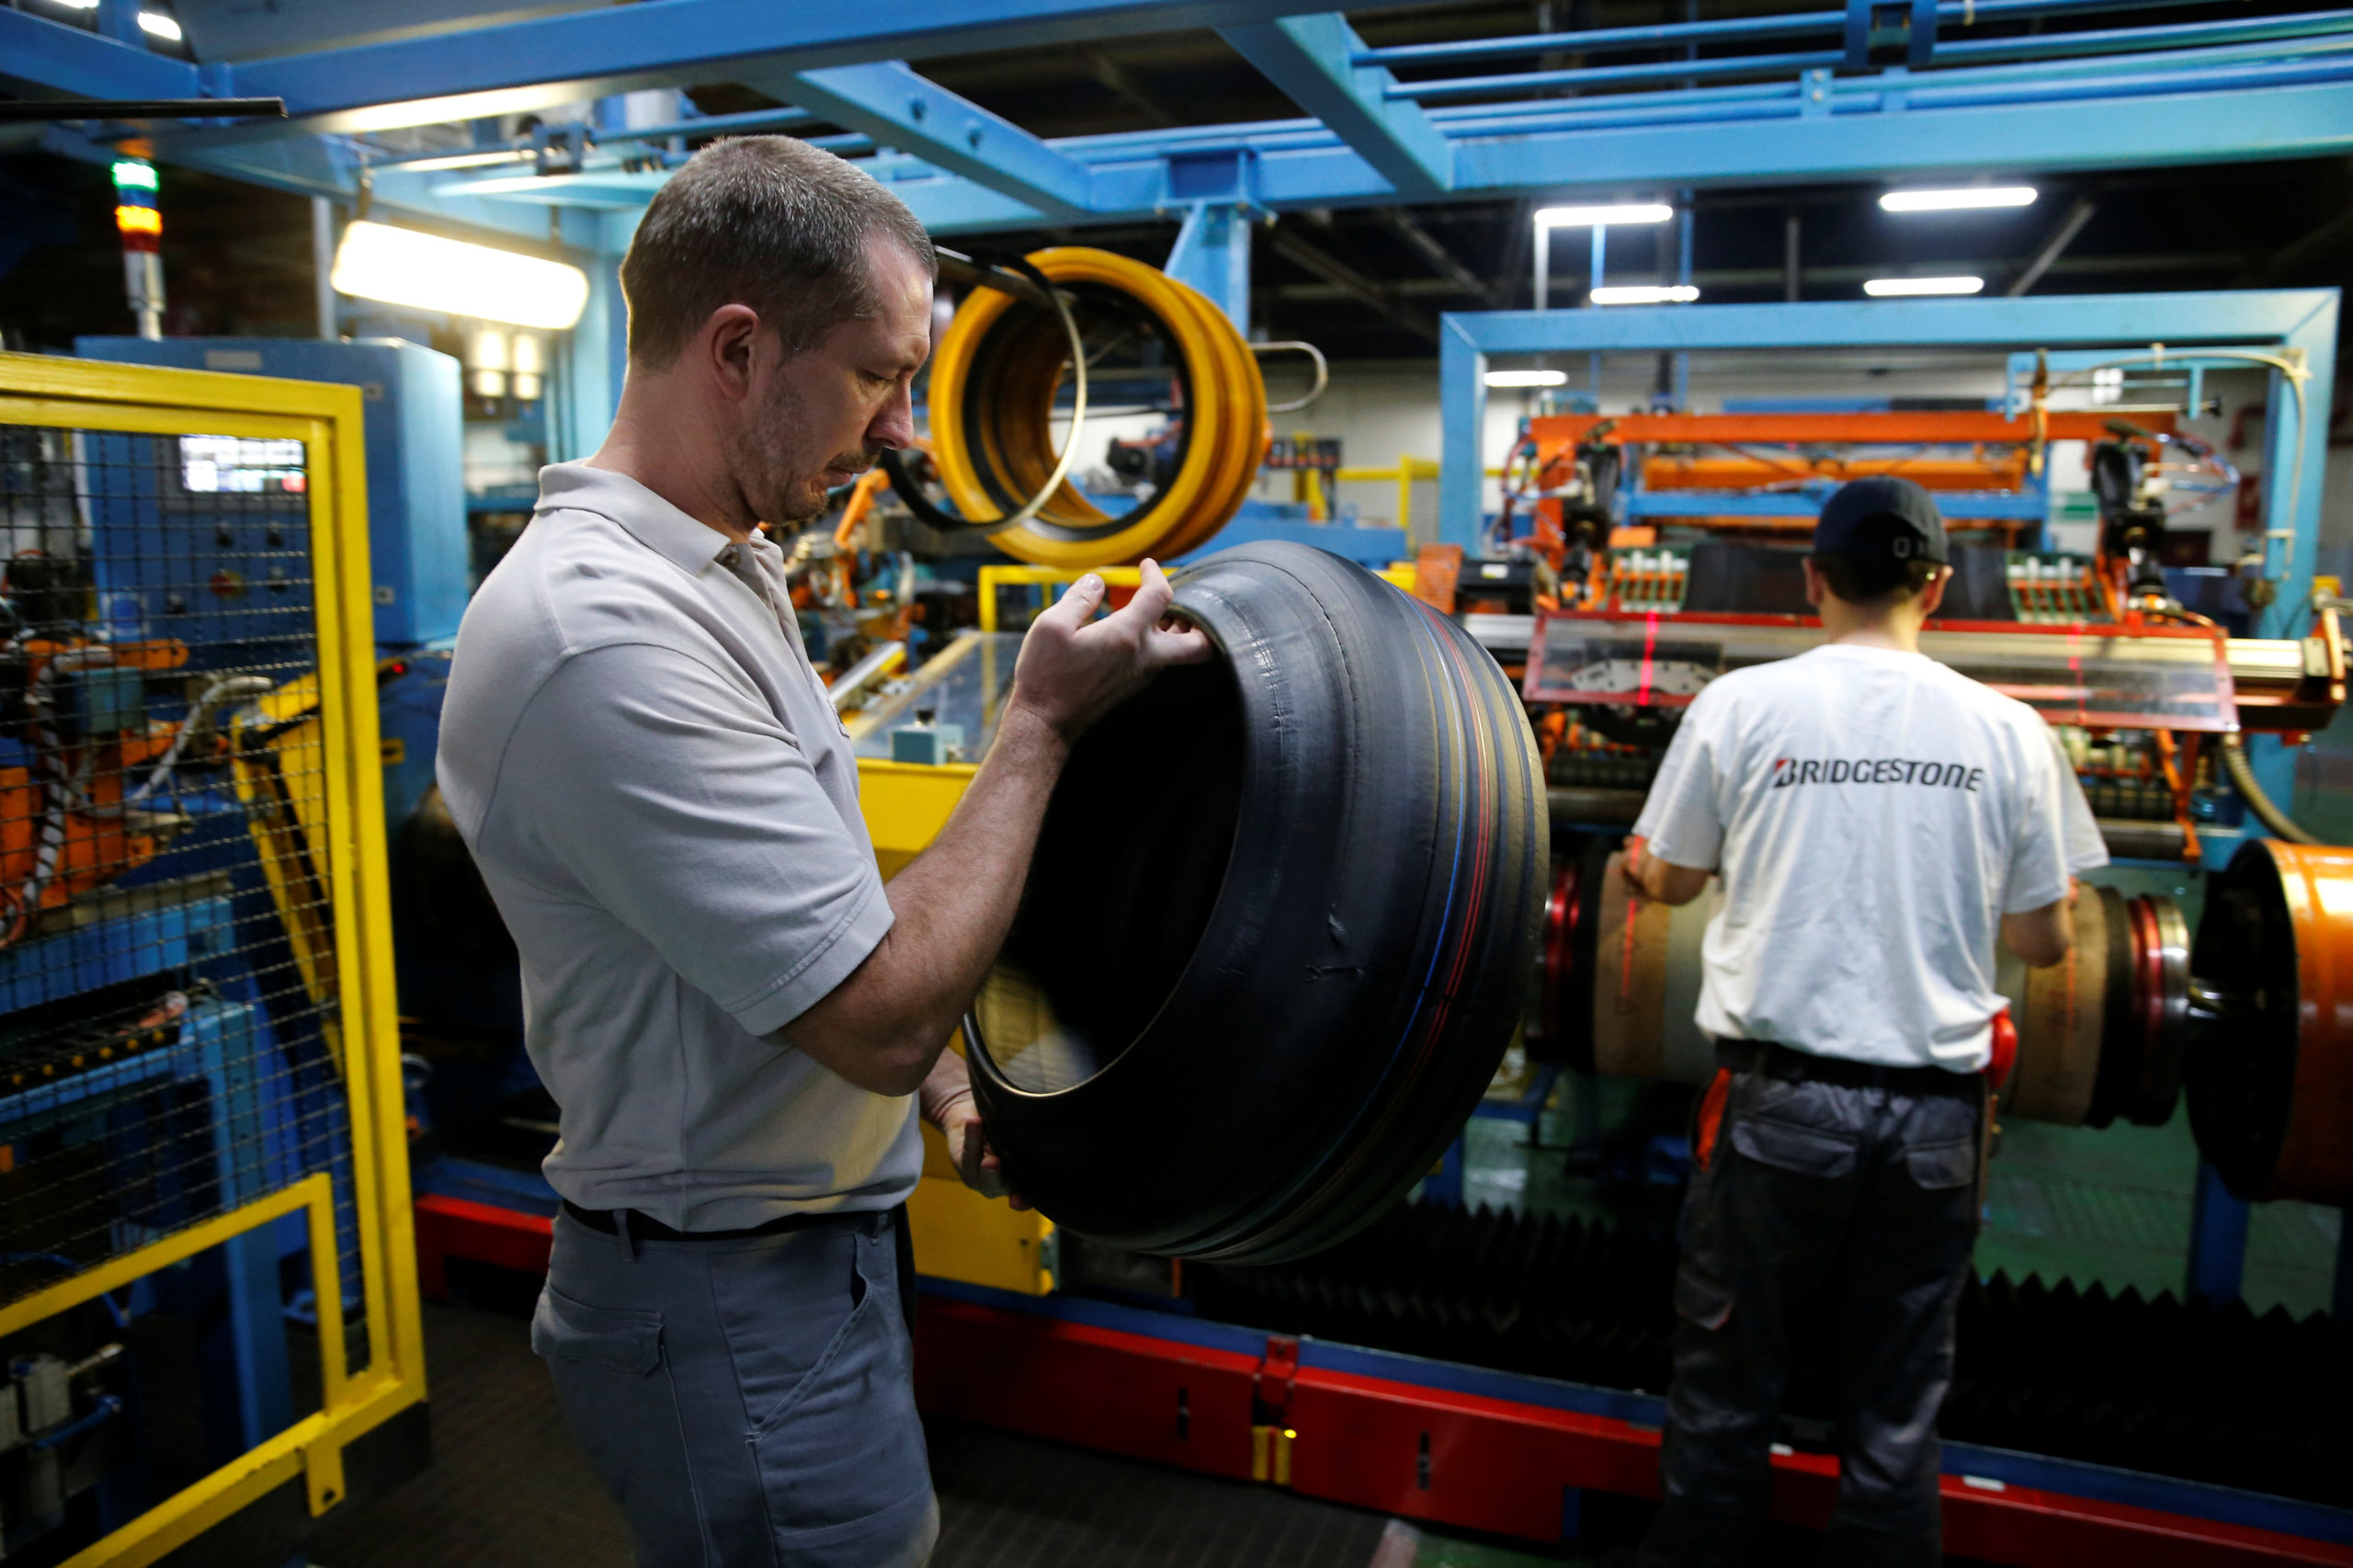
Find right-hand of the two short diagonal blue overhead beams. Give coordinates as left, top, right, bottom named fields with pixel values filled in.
left=1219, top=12, right=1454, bottom=198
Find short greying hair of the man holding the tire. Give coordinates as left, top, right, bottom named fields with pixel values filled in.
left=621, top=137, right=938, bottom=369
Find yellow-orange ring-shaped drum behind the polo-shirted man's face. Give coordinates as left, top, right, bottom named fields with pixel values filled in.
left=892, top=244, right=1270, bottom=570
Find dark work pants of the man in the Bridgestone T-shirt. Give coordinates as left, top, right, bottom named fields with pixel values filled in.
left=1643, top=1052, right=1984, bottom=1568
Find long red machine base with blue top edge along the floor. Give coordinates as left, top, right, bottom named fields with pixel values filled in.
left=416, top=1194, right=2353, bottom=1568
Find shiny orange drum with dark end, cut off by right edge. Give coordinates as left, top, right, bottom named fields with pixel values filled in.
left=2186, top=838, right=2353, bottom=1206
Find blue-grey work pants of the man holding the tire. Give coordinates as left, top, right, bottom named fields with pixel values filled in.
left=532, top=1212, right=938, bottom=1568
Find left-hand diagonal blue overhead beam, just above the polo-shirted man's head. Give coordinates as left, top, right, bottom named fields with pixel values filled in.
left=781, top=62, right=1094, bottom=223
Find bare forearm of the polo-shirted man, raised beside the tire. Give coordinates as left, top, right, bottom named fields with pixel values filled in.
left=786, top=701, right=1071, bottom=1095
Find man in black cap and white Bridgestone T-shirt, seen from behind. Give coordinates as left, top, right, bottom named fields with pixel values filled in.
left=1626, top=475, right=2106, bottom=1568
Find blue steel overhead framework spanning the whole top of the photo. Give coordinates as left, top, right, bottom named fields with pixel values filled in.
left=0, top=0, right=2353, bottom=252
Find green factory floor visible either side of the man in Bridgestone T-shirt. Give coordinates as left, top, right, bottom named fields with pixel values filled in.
left=1463, top=1074, right=2341, bottom=1318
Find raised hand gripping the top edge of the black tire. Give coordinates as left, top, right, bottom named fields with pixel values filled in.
left=1009, top=561, right=1211, bottom=744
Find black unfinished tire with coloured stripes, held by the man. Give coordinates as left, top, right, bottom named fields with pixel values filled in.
left=972, top=544, right=1551, bottom=1262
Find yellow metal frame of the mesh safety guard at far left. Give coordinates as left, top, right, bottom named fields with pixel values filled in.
left=0, top=353, right=426, bottom=1568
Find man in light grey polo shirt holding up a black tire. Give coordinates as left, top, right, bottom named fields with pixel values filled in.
left=440, top=137, right=1210, bottom=1568
